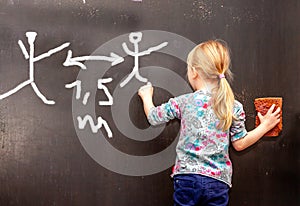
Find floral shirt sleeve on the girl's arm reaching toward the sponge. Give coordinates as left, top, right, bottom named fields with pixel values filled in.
left=230, top=101, right=247, bottom=142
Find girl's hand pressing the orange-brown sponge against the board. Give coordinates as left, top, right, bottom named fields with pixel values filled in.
left=257, top=104, right=280, bottom=131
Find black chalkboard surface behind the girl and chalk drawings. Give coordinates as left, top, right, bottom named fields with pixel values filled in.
left=0, top=0, right=300, bottom=206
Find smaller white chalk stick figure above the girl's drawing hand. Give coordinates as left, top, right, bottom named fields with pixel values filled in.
left=120, top=32, right=168, bottom=87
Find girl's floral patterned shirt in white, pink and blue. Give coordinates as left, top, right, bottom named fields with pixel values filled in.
left=148, top=90, right=247, bottom=187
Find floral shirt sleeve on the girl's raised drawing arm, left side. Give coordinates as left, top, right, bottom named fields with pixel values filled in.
left=147, top=98, right=181, bottom=125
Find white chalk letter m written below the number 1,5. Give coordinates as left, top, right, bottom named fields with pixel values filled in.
left=77, top=115, right=113, bottom=138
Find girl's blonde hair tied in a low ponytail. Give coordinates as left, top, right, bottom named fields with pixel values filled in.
left=187, top=40, right=234, bottom=131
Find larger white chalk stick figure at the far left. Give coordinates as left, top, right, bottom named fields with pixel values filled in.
left=0, top=32, right=70, bottom=104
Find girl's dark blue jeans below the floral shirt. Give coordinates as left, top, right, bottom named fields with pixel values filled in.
left=173, top=174, right=229, bottom=206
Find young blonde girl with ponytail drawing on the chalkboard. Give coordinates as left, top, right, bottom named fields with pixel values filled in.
left=138, top=41, right=280, bottom=206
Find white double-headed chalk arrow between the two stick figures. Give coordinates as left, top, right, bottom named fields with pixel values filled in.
left=63, top=50, right=124, bottom=69
